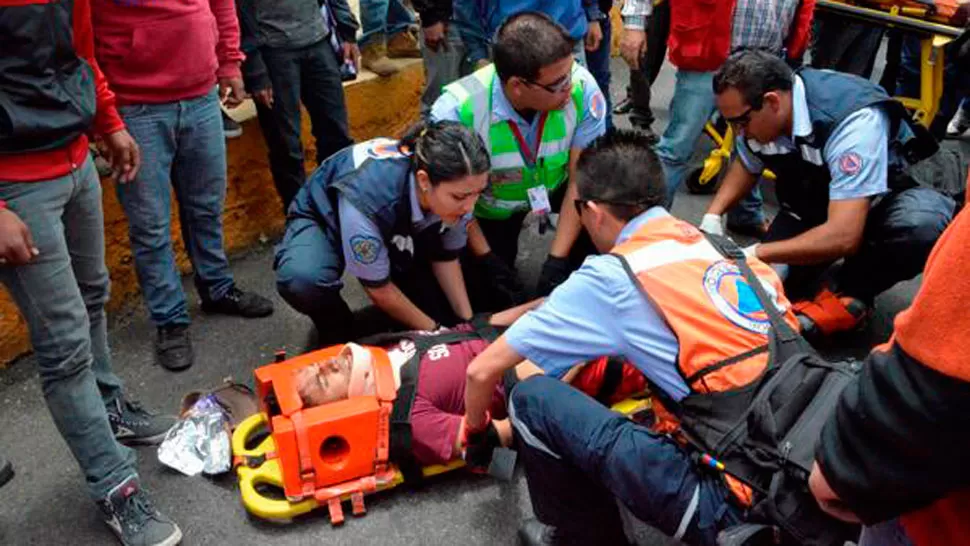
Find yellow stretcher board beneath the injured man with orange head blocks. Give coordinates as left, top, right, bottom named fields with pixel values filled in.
left=232, top=398, right=650, bottom=524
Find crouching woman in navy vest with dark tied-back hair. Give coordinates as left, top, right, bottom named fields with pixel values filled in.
left=275, top=122, right=490, bottom=346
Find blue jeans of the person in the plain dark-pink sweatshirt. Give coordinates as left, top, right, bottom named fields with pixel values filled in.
left=117, top=88, right=233, bottom=326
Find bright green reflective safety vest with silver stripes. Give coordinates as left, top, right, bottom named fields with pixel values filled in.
left=444, top=63, right=585, bottom=220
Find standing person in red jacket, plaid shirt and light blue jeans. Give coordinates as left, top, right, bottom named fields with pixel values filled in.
left=657, top=0, right=815, bottom=236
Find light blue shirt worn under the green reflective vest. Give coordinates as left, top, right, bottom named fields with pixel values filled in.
left=431, top=66, right=606, bottom=150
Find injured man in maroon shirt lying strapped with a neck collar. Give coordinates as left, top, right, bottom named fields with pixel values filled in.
left=294, top=300, right=647, bottom=467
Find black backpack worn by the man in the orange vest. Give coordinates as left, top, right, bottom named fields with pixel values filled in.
left=688, top=235, right=860, bottom=546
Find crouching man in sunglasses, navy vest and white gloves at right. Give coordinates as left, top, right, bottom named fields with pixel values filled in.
left=700, top=51, right=962, bottom=335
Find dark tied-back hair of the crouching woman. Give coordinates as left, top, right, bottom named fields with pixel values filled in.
left=399, top=120, right=491, bottom=186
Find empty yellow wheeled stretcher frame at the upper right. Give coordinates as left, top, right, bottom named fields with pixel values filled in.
left=686, top=0, right=963, bottom=194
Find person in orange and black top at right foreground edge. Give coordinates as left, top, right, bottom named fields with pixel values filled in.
left=809, top=188, right=970, bottom=546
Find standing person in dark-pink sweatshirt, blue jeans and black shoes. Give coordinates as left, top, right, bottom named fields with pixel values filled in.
left=92, top=0, right=273, bottom=370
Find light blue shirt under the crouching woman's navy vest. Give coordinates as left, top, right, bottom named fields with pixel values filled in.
left=337, top=176, right=470, bottom=285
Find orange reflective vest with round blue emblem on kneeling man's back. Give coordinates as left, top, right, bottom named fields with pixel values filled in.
left=612, top=216, right=798, bottom=504
